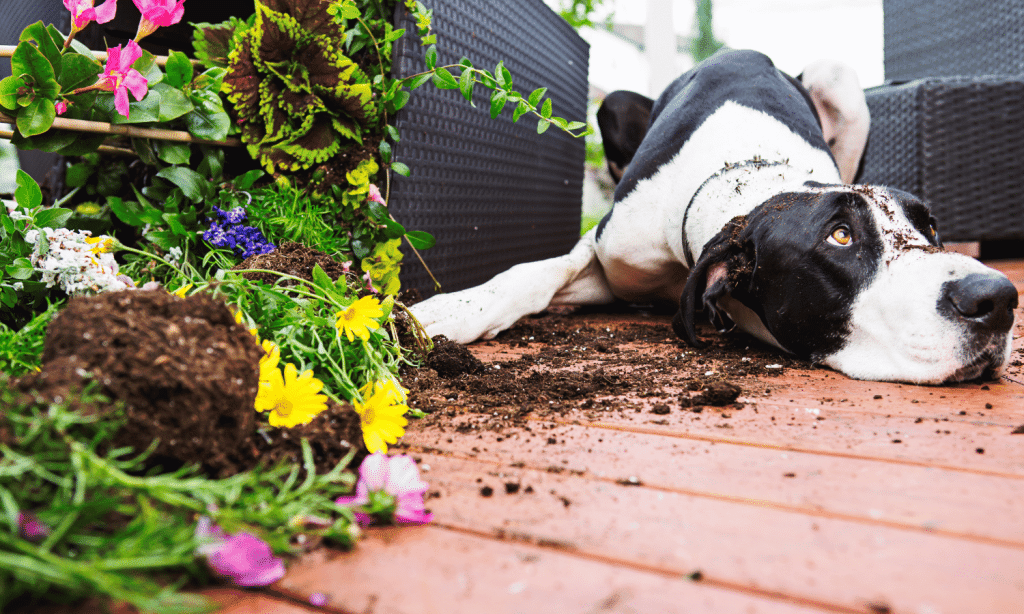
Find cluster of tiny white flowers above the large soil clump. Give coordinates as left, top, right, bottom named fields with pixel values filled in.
left=25, top=228, right=135, bottom=296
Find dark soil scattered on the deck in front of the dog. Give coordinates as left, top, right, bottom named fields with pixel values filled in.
left=402, top=304, right=807, bottom=432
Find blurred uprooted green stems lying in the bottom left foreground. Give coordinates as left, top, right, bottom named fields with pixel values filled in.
left=0, top=375, right=354, bottom=613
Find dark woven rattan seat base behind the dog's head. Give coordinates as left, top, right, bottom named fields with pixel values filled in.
left=862, top=77, right=1024, bottom=240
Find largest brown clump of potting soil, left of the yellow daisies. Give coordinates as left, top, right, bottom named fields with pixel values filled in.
left=18, top=291, right=263, bottom=474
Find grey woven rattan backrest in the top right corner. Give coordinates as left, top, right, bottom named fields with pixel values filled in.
left=885, top=0, right=1024, bottom=81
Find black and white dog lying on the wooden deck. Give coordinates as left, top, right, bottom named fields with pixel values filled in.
left=413, top=51, right=1018, bottom=384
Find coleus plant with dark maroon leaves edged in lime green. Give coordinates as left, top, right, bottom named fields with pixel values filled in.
left=224, top=0, right=376, bottom=173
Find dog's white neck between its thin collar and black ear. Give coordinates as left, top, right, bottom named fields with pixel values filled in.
left=683, top=157, right=819, bottom=267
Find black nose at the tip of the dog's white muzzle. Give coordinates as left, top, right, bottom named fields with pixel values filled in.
left=940, top=273, right=1017, bottom=332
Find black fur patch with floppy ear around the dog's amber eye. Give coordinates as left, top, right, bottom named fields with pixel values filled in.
left=673, top=188, right=883, bottom=360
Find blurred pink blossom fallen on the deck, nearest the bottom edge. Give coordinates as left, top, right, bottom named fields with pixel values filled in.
left=196, top=516, right=285, bottom=586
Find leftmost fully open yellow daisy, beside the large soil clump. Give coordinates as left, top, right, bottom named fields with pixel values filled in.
left=256, top=362, right=327, bottom=428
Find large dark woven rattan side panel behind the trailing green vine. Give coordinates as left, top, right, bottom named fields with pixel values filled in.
left=389, top=0, right=590, bottom=296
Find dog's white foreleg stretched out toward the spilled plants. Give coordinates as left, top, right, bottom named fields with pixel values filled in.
left=411, top=230, right=613, bottom=343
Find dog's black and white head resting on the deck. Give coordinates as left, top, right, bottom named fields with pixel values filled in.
left=673, top=183, right=1017, bottom=384
